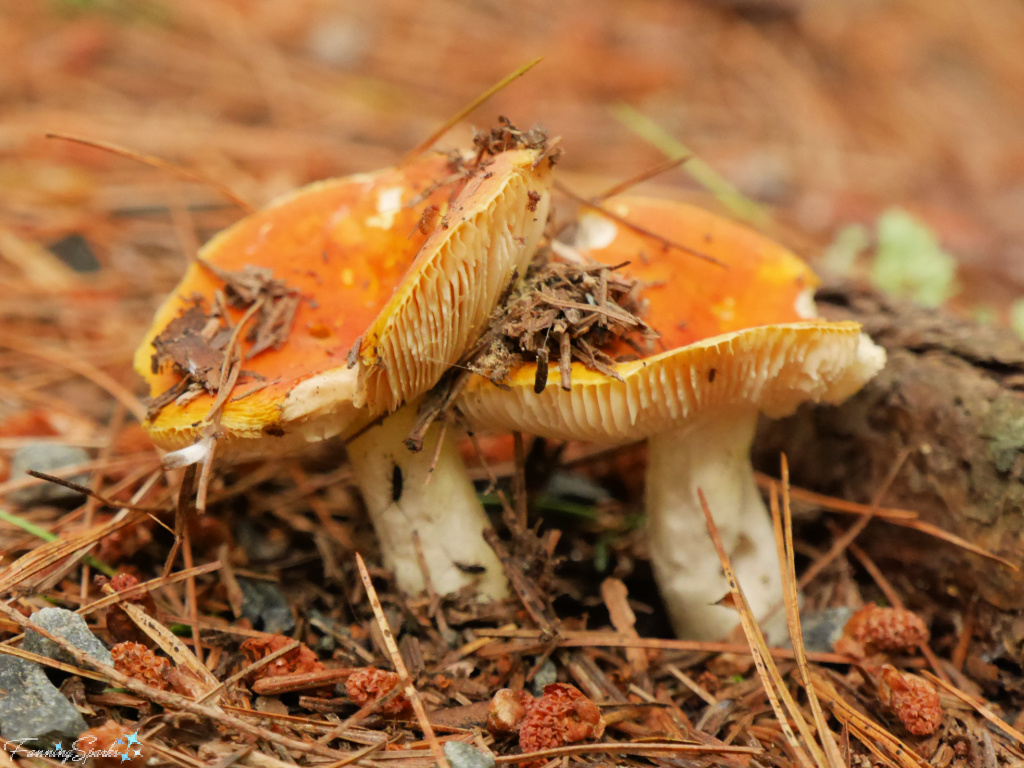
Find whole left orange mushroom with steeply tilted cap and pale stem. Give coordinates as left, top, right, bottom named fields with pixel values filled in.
left=135, top=148, right=550, bottom=598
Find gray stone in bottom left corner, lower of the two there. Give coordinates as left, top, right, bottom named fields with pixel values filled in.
left=0, top=655, right=88, bottom=750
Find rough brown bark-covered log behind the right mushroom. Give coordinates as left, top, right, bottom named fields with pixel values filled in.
left=756, top=283, right=1024, bottom=610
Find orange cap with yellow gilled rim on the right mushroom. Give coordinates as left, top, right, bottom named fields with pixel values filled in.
left=459, top=198, right=884, bottom=442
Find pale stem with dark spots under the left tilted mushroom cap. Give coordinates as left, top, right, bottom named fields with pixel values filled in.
left=348, top=403, right=508, bottom=599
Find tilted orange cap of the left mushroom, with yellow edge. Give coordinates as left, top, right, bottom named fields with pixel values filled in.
left=135, top=151, right=549, bottom=452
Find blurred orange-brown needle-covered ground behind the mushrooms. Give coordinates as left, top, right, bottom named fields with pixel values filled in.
left=0, top=0, right=1024, bottom=444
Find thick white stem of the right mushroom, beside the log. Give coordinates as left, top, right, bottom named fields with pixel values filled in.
left=646, top=407, right=785, bottom=641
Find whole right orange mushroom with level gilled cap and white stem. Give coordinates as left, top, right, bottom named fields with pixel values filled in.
left=457, top=198, right=885, bottom=639
